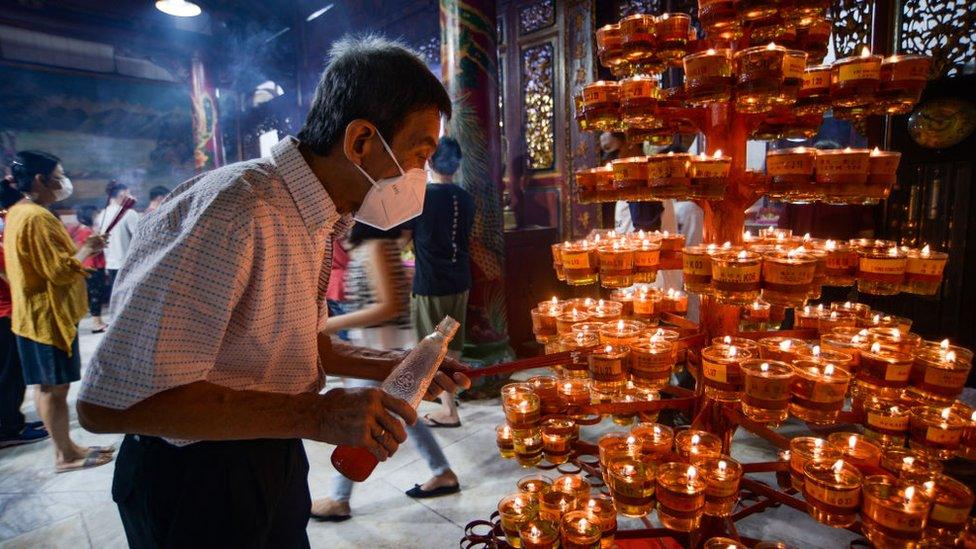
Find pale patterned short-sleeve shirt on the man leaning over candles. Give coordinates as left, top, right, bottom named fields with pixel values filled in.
left=79, top=137, right=351, bottom=444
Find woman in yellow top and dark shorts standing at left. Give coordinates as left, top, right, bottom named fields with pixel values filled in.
left=2, top=151, right=114, bottom=473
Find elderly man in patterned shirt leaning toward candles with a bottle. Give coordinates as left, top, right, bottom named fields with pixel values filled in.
left=78, top=37, right=469, bottom=547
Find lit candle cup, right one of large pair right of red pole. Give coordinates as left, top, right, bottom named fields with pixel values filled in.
left=790, top=360, right=851, bottom=425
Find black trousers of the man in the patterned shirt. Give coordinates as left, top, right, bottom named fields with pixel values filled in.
left=112, top=435, right=312, bottom=549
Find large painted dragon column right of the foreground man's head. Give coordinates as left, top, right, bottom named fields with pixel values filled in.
left=440, top=0, right=514, bottom=364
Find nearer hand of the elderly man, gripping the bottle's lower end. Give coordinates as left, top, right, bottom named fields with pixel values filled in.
left=308, top=388, right=417, bottom=461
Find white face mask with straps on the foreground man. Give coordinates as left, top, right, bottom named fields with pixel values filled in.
left=353, top=131, right=427, bottom=231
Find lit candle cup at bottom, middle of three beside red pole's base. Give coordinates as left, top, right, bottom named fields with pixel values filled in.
left=657, top=462, right=707, bottom=532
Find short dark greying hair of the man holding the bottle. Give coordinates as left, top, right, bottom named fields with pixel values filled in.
left=298, top=35, right=451, bottom=156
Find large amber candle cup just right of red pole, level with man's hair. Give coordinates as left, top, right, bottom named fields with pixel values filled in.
left=733, top=42, right=788, bottom=114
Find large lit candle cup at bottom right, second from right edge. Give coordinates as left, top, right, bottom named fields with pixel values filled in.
left=861, top=475, right=932, bottom=549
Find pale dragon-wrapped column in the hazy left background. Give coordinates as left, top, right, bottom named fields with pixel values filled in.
left=190, top=53, right=224, bottom=173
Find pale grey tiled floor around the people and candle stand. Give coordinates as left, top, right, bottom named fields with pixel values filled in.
left=0, top=316, right=868, bottom=549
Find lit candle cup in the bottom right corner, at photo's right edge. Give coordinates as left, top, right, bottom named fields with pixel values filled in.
left=923, top=475, right=973, bottom=547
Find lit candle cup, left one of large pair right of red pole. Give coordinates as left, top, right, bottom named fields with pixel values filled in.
left=740, top=359, right=793, bottom=427
